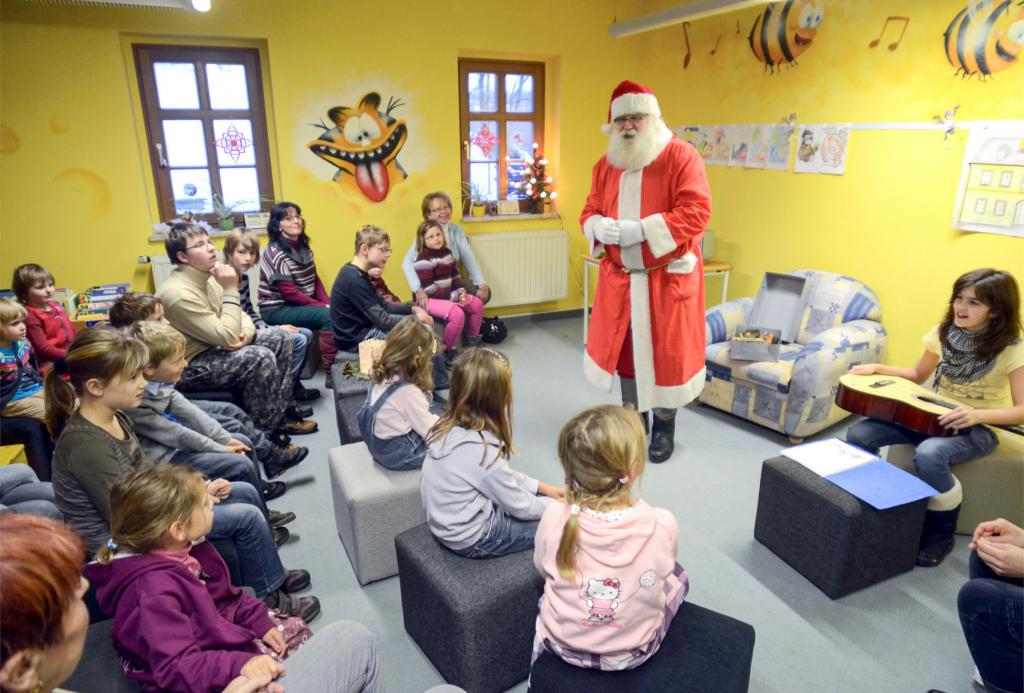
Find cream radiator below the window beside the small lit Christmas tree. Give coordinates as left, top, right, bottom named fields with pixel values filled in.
left=467, top=228, right=569, bottom=308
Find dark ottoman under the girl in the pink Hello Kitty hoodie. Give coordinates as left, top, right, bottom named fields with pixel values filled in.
left=529, top=602, right=754, bottom=693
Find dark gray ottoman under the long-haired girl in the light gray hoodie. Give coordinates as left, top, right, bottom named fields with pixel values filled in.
left=394, top=524, right=544, bottom=693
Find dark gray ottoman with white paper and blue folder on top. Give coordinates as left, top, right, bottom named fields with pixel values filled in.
left=754, top=457, right=928, bottom=599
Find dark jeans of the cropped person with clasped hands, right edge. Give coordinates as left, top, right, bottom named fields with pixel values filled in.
left=957, top=553, right=1024, bottom=693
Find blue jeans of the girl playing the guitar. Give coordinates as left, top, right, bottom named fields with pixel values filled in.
left=846, top=419, right=999, bottom=493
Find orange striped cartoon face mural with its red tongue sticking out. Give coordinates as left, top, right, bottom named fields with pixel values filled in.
left=306, top=91, right=409, bottom=202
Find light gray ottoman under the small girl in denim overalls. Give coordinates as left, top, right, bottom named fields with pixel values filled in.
left=328, top=442, right=426, bottom=584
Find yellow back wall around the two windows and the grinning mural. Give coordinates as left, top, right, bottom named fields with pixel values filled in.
left=0, top=0, right=642, bottom=310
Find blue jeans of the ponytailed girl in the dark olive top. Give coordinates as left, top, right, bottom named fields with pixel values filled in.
left=210, top=482, right=285, bottom=599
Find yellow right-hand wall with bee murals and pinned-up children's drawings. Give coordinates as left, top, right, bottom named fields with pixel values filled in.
left=642, top=0, right=1024, bottom=364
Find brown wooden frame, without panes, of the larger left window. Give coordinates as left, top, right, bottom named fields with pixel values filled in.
left=132, top=43, right=274, bottom=223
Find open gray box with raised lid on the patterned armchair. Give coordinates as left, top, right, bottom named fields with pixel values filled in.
left=729, top=272, right=809, bottom=361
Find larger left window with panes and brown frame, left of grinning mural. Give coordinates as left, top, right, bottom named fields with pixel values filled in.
left=134, top=45, right=273, bottom=220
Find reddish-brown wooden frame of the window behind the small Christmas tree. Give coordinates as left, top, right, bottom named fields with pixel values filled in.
left=459, top=57, right=546, bottom=212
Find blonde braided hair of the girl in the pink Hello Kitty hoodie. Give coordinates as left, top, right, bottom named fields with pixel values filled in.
left=555, top=404, right=646, bottom=579
